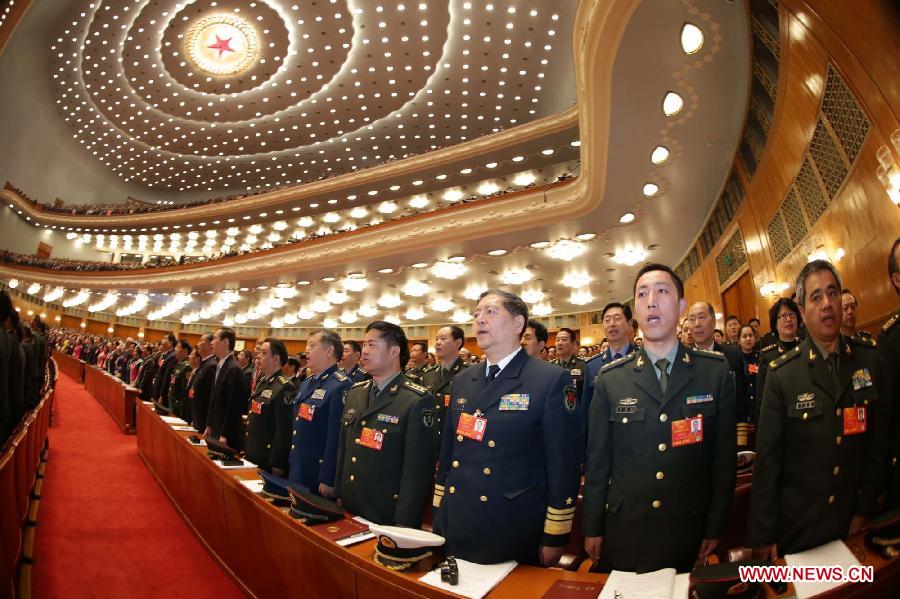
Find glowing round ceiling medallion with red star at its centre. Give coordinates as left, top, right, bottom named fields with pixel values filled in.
left=184, top=14, right=260, bottom=77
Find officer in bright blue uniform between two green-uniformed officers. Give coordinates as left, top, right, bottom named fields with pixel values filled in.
left=288, top=329, right=351, bottom=498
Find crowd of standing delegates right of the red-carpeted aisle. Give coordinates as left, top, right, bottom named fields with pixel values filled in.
left=42, top=240, right=900, bottom=572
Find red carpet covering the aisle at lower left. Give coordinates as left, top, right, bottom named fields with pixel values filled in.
left=32, top=374, right=244, bottom=599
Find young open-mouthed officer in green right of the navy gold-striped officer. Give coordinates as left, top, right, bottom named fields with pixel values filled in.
left=582, top=264, right=737, bottom=572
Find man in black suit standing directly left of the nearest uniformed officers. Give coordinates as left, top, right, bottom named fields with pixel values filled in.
left=204, top=327, right=250, bottom=450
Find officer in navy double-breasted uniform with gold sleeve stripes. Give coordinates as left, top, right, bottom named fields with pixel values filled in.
left=433, top=290, right=583, bottom=566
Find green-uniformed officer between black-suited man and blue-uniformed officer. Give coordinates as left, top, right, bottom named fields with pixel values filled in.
left=244, top=337, right=294, bottom=476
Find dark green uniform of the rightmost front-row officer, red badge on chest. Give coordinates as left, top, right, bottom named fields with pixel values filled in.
left=747, top=337, right=889, bottom=554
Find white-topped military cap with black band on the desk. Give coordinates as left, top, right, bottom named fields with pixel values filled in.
left=369, top=524, right=444, bottom=572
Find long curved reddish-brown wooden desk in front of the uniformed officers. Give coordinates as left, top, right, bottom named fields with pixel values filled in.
left=130, top=401, right=900, bottom=599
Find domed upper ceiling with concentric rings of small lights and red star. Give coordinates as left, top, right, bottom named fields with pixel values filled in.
left=51, top=0, right=575, bottom=191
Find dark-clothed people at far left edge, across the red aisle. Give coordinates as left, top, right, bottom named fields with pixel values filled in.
left=0, top=290, right=55, bottom=446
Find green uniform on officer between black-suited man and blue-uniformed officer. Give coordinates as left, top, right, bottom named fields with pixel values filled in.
left=244, top=370, right=296, bottom=473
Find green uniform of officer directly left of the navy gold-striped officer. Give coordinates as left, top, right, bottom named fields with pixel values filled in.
left=335, top=373, right=438, bottom=528
